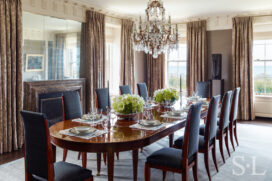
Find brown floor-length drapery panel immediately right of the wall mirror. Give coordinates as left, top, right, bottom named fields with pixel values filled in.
left=80, top=10, right=105, bottom=110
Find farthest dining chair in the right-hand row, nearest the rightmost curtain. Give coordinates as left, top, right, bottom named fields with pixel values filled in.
left=229, top=87, right=240, bottom=151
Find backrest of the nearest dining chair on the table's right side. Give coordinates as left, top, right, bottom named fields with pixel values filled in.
left=182, top=102, right=202, bottom=159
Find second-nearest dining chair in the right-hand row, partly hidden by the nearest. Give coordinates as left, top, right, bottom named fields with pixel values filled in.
left=174, top=95, right=220, bottom=181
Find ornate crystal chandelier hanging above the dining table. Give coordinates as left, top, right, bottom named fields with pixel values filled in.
left=132, top=0, right=178, bottom=58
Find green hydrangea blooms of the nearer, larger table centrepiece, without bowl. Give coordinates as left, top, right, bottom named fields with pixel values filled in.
left=112, top=94, right=144, bottom=114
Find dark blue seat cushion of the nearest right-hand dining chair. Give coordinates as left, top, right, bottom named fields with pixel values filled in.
left=147, top=148, right=182, bottom=169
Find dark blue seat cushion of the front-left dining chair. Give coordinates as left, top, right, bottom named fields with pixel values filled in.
left=54, top=162, right=92, bottom=181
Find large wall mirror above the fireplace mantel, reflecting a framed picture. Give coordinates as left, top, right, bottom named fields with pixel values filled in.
left=23, top=12, right=81, bottom=81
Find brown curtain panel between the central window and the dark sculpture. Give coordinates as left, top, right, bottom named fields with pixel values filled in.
left=187, top=20, right=207, bottom=96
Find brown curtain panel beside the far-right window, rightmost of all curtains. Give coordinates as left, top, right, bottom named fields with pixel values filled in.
left=232, top=17, right=255, bottom=120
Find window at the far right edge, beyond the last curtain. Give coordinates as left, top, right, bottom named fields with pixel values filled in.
left=253, top=39, right=272, bottom=95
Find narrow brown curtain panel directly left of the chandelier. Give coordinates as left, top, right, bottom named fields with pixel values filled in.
left=120, top=20, right=135, bottom=92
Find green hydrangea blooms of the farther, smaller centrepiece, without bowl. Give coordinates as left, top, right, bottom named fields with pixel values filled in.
left=154, top=88, right=179, bottom=103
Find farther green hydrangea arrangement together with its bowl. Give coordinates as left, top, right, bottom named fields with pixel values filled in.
left=154, top=88, right=179, bottom=108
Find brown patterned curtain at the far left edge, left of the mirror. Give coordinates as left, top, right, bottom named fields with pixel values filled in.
left=0, top=0, right=23, bottom=153
